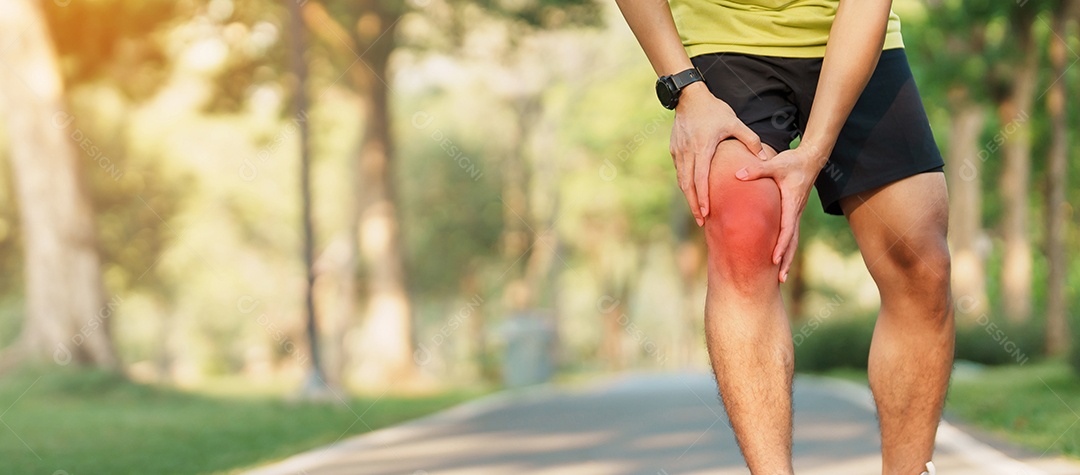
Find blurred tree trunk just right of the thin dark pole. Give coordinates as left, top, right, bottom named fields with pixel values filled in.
left=351, top=10, right=416, bottom=385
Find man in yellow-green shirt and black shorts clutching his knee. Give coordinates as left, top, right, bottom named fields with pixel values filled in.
left=618, top=0, right=954, bottom=475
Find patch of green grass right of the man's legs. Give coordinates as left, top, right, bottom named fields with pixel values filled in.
left=946, top=363, right=1080, bottom=457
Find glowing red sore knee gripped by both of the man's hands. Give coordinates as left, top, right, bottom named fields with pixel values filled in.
left=704, top=144, right=780, bottom=291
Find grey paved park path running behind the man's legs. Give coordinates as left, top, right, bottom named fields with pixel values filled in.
left=248, top=374, right=1080, bottom=475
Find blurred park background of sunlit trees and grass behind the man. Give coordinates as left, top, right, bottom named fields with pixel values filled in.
left=0, top=0, right=1080, bottom=474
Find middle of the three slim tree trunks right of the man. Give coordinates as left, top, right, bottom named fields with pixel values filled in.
left=1000, top=15, right=1040, bottom=323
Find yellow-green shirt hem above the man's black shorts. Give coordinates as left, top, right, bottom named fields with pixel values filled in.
left=670, top=0, right=904, bottom=57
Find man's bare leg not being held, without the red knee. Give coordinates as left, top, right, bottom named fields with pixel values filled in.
left=840, top=173, right=954, bottom=475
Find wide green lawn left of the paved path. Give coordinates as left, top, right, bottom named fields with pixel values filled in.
left=0, top=371, right=480, bottom=475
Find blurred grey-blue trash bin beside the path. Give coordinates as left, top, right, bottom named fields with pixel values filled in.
left=501, top=314, right=554, bottom=388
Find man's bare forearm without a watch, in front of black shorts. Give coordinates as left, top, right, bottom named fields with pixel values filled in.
left=799, top=0, right=892, bottom=166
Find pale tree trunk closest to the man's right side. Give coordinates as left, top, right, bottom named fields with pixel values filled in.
left=945, top=98, right=989, bottom=323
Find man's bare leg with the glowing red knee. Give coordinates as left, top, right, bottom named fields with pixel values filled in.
left=705, top=140, right=794, bottom=475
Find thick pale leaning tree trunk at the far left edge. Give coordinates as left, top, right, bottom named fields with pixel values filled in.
left=0, top=0, right=117, bottom=367
